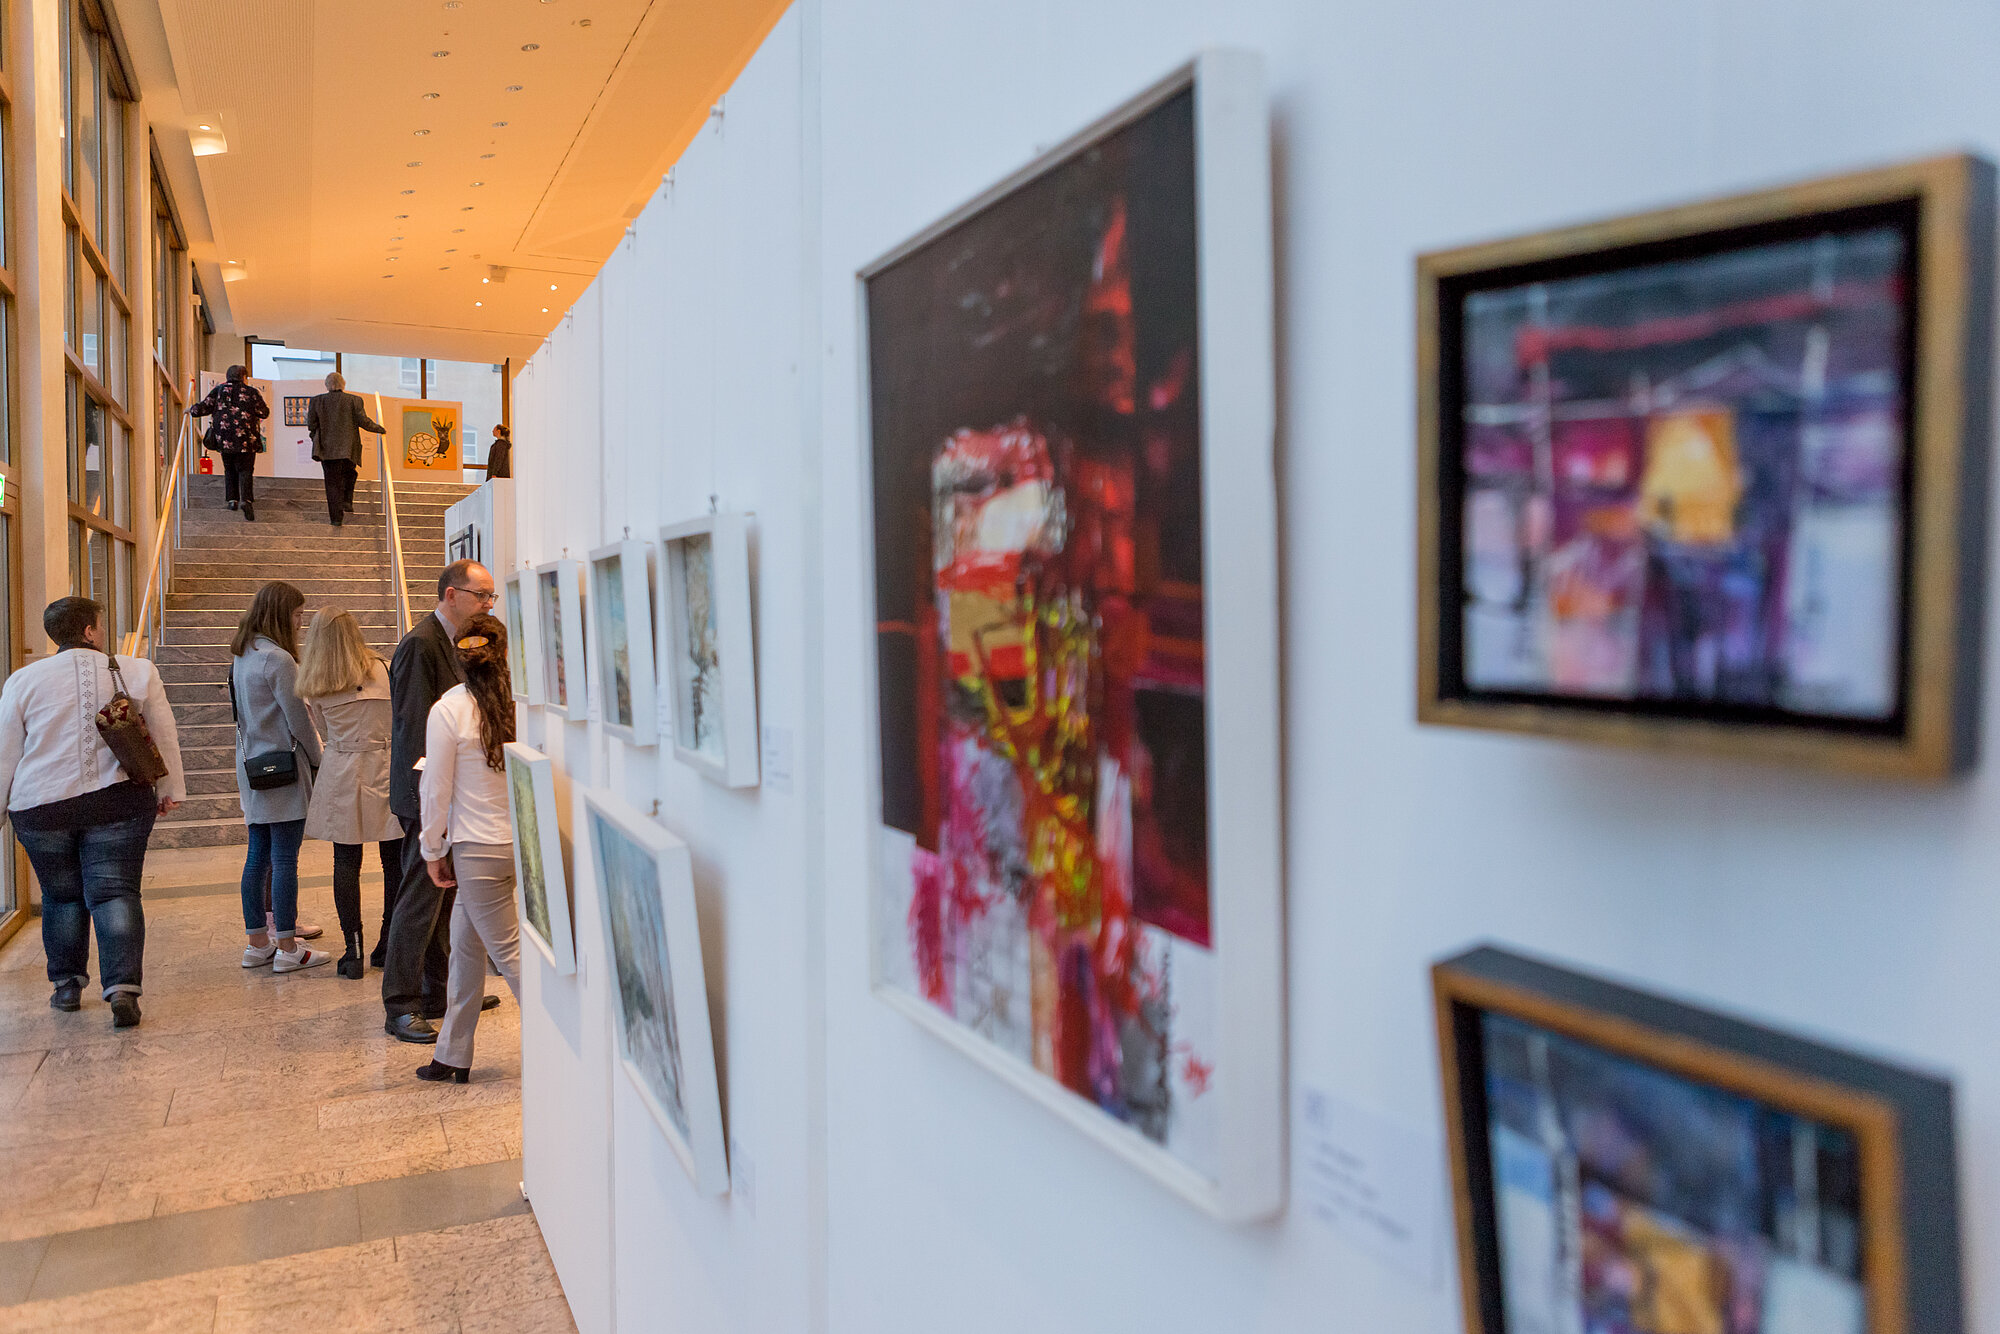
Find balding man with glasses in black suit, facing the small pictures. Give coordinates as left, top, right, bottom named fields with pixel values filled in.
left=382, top=560, right=494, bottom=1042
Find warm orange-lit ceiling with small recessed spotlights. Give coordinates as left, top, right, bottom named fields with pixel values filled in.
left=125, top=0, right=784, bottom=362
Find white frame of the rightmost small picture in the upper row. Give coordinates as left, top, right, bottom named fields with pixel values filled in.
left=660, top=514, right=762, bottom=788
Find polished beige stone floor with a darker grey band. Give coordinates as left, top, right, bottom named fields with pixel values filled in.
left=0, top=844, right=572, bottom=1334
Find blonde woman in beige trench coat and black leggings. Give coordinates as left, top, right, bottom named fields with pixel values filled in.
left=298, top=608, right=402, bottom=978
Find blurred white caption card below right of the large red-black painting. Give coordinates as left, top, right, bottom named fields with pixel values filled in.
left=1296, top=1088, right=1444, bottom=1288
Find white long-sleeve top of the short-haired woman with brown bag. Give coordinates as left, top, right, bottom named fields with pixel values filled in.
left=0, top=648, right=188, bottom=810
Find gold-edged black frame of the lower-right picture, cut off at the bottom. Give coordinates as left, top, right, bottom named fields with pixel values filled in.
left=1432, top=946, right=1964, bottom=1334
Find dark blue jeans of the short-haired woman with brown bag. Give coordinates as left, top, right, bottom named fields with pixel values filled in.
left=14, top=810, right=156, bottom=1000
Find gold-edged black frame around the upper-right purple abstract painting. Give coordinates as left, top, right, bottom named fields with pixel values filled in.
left=1418, top=156, right=1994, bottom=780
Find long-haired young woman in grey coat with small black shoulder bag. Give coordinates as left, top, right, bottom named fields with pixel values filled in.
left=230, top=580, right=334, bottom=972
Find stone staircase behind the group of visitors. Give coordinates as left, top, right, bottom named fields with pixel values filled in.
left=152, top=476, right=472, bottom=848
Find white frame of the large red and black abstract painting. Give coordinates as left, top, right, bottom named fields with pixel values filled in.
left=856, top=50, right=1286, bottom=1222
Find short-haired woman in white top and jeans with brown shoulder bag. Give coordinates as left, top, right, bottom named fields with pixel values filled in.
left=0, top=598, right=188, bottom=1028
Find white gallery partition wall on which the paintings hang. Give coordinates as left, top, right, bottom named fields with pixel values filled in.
left=516, top=0, right=2000, bottom=1334
